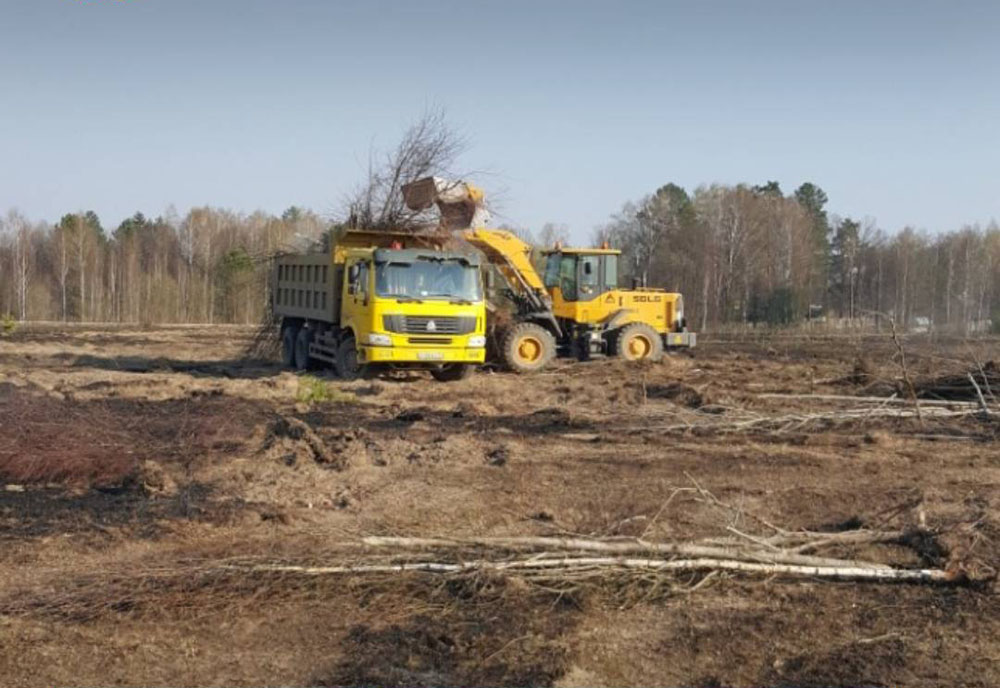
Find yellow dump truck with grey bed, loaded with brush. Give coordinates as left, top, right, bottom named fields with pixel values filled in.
left=272, top=231, right=486, bottom=381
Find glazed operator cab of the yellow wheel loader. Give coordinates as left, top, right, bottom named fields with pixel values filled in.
left=544, top=248, right=621, bottom=302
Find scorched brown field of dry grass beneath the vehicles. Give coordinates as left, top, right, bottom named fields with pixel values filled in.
left=0, top=326, right=1000, bottom=687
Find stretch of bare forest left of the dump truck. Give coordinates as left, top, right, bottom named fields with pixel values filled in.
left=0, top=207, right=327, bottom=323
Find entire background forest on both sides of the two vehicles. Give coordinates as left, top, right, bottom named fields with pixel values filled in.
left=0, top=182, right=1000, bottom=333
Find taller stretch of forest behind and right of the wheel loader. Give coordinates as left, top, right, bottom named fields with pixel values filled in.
left=595, top=181, right=1000, bottom=333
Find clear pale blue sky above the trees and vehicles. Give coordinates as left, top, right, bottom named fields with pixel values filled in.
left=0, top=0, right=1000, bottom=240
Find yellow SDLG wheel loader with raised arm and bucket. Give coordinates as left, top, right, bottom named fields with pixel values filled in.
left=403, top=177, right=697, bottom=373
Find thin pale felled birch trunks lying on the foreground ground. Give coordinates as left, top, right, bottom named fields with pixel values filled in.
left=276, top=530, right=962, bottom=583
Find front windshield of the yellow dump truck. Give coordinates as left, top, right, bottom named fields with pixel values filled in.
left=375, top=259, right=482, bottom=301
